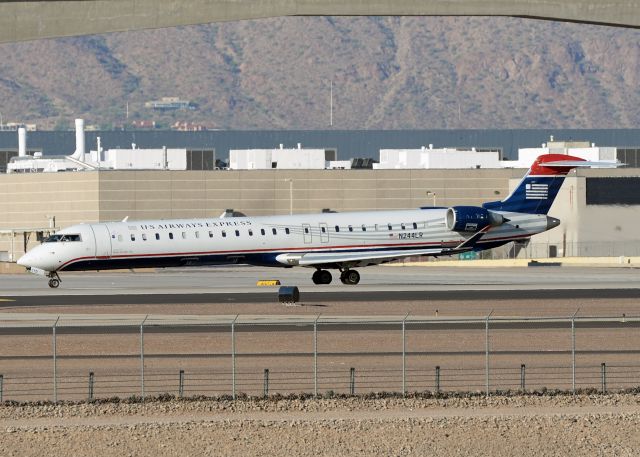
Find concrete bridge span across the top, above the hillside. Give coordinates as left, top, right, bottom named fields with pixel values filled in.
left=0, top=0, right=640, bottom=43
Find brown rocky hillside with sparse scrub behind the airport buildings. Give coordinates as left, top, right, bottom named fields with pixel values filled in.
left=0, top=17, right=640, bottom=129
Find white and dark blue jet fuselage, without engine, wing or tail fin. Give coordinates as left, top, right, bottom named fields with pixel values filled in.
left=19, top=208, right=549, bottom=272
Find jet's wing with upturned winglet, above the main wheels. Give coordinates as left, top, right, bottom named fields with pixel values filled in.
left=277, top=227, right=490, bottom=267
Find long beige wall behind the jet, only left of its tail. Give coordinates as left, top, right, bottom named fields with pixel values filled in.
left=0, top=170, right=523, bottom=256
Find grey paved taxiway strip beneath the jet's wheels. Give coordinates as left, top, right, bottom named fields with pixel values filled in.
left=0, top=267, right=640, bottom=309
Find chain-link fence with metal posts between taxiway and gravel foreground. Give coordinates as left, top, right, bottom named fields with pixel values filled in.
left=0, top=311, right=640, bottom=402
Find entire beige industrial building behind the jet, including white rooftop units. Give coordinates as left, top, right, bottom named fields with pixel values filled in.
left=0, top=122, right=640, bottom=261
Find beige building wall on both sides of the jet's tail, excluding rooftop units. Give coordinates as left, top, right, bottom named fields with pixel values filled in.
left=0, top=169, right=640, bottom=257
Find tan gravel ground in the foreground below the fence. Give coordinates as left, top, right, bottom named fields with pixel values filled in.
left=0, top=394, right=640, bottom=456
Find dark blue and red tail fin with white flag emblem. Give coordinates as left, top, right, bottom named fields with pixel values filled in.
left=482, top=154, right=604, bottom=214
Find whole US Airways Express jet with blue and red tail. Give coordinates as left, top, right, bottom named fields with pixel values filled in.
left=18, top=154, right=616, bottom=287
